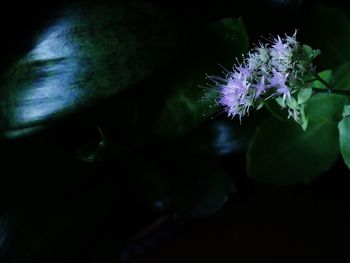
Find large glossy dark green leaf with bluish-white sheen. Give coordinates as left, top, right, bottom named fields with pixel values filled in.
left=0, top=2, right=179, bottom=139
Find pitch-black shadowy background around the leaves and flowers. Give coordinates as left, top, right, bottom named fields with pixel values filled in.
left=0, top=0, right=350, bottom=263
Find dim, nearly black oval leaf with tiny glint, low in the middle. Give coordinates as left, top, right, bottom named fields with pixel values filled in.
left=129, top=156, right=235, bottom=217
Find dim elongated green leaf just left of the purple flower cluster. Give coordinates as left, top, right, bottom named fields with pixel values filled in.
left=153, top=19, right=248, bottom=137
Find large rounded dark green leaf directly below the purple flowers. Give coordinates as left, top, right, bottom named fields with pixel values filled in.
left=247, top=94, right=346, bottom=185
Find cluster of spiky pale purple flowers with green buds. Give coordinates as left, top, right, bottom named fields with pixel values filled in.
left=209, top=32, right=320, bottom=128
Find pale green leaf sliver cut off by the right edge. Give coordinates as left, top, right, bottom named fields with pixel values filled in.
left=338, top=105, right=350, bottom=168
